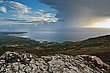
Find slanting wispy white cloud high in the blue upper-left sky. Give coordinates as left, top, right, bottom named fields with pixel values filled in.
left=5, top=1, right=30, bottom=13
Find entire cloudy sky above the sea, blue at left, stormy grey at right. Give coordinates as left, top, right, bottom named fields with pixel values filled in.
left=0, top=0, right=110, bottom=28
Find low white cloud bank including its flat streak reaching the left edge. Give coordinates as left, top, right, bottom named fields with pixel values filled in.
left=0, top=10, right=58, bottom=24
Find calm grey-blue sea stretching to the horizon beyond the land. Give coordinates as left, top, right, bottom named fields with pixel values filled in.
left=0, top=26, right=110, bottom=42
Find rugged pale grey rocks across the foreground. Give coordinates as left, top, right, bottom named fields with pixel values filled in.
left=0, top=52, right=110, bottom=73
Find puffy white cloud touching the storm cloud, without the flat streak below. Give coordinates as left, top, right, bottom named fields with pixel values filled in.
left=14, top=10, right=58, bottom=22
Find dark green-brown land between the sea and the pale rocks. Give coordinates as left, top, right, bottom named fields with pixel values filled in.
left=0, top=35, right=110, bottom=64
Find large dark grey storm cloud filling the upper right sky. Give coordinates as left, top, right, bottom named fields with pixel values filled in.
left=40, top=0, right=110, bottom=26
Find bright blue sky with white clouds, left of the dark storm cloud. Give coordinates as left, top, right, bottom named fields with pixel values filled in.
left=0, top=0, right=59, bottom=25
